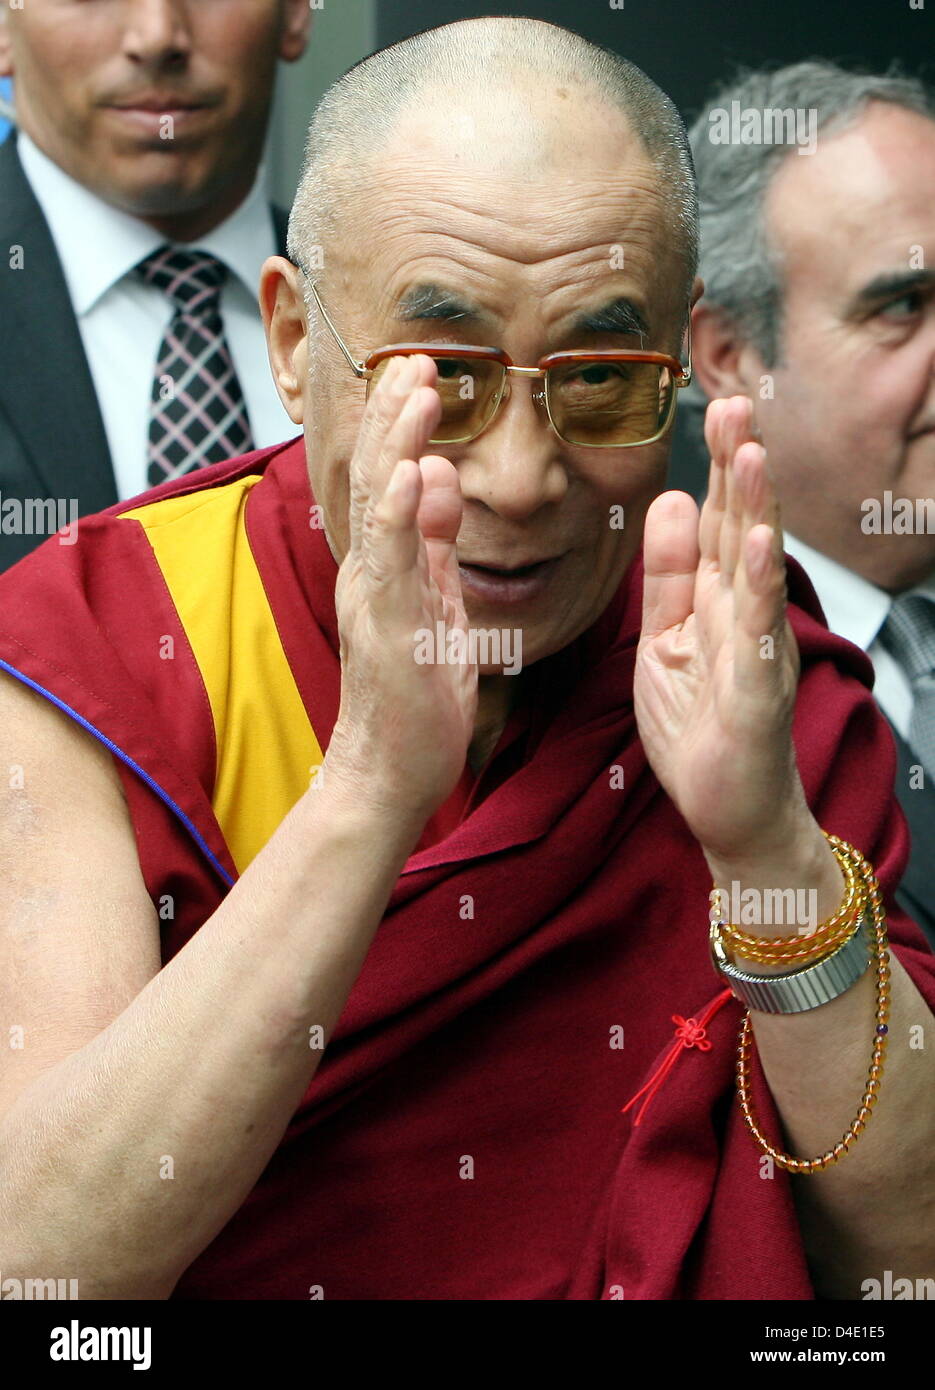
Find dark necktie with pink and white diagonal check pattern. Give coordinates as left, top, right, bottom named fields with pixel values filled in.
left=136, top=246, right=253, bottom=488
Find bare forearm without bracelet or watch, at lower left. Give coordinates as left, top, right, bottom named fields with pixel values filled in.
left=0, top=787, right=421, bottom=1298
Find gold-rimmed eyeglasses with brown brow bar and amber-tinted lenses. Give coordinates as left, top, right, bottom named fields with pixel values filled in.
left=308, top=281, right=692, bottom=449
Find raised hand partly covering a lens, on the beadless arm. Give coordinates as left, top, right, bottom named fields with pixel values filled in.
left=325, top=356, right=477, bottom=821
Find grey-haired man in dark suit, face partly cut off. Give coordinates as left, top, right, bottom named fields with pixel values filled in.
left=692, top=63, right=935, bottom=947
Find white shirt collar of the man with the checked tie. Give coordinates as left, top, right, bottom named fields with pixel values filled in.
left=17, top=131, right=278, bottom=318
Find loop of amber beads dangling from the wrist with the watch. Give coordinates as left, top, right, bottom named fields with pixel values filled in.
left=736, top=835, right=891, bottom=1173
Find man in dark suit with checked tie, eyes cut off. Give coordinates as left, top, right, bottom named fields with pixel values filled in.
left=0, top=0, right=310, bottom=569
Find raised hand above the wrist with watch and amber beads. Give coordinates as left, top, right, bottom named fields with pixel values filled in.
left=634, top=396, right=810, bottom=862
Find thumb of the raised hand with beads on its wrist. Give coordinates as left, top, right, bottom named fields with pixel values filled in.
left=642, top=492, right=699, bottom=639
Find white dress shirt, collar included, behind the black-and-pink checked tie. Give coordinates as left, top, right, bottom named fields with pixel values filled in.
left=17, top=131, right=299, bottom=500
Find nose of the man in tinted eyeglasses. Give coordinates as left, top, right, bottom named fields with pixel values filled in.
left=457, top=378, right=568, bottom=521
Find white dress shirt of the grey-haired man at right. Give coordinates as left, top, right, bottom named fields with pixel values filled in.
left=785, top=532, right=935, bottom=739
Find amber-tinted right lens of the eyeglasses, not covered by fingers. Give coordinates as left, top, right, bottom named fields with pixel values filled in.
left=546, top=360, right=675, bottom=446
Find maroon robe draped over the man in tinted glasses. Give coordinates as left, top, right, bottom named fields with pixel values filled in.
left=0, top=441, right=935, bottom=1300
